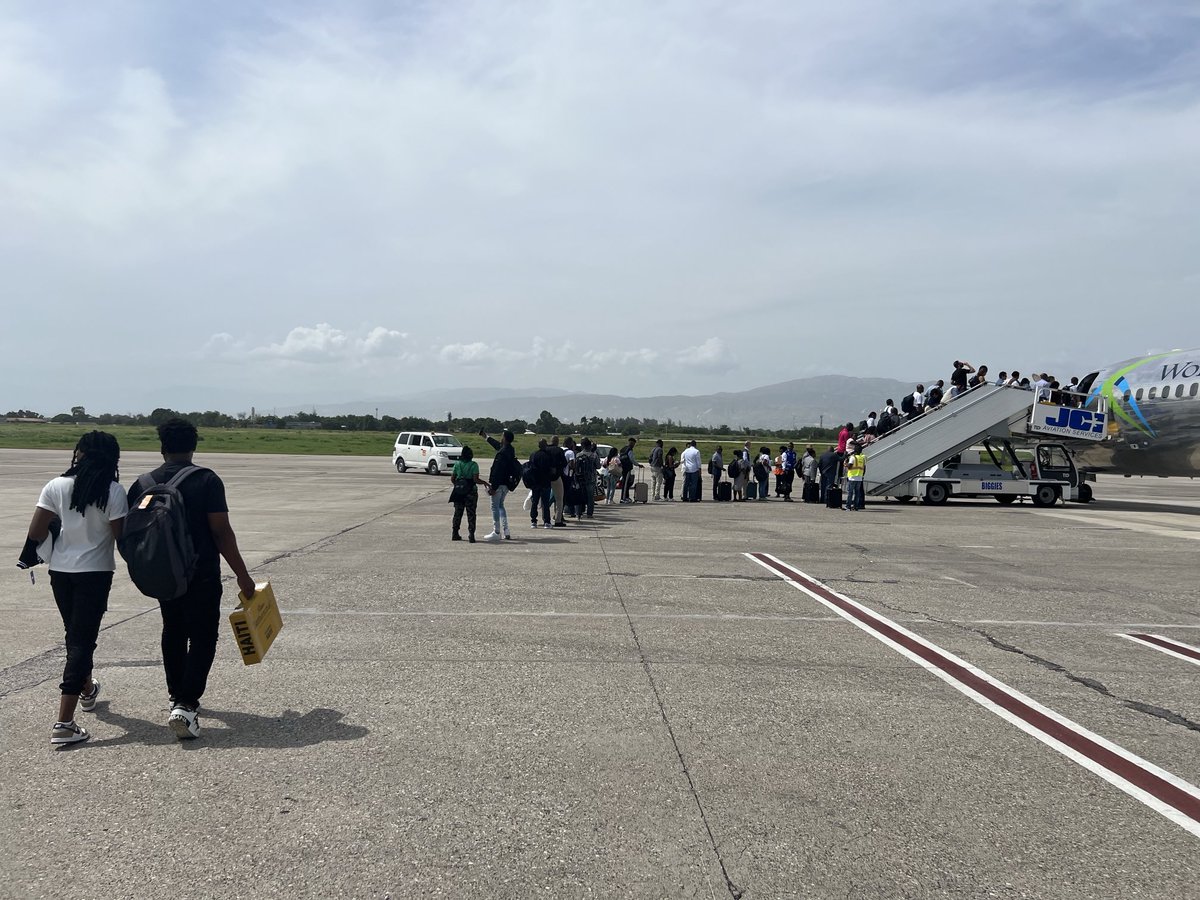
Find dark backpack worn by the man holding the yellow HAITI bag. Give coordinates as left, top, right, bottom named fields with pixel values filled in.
left=116, top=466, right=200, bottom=600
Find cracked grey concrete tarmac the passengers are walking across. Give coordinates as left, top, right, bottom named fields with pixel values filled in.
left=0, top=450, right=1200, bottom=900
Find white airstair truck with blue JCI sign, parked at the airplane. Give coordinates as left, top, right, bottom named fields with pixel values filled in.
left=864, top=385, right=1105, bottom=506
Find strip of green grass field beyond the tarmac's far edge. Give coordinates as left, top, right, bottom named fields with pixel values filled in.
left=0, top=424, right=822, bottom=461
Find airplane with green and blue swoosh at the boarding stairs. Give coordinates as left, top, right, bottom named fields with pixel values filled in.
left=1070, top=349, right=1200, bottom=478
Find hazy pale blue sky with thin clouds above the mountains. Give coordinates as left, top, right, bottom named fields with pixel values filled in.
left=0, top=0, right=1200, bottom=415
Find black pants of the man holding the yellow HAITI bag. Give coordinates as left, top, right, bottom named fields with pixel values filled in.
left=158, top=570, right=221, bottom=707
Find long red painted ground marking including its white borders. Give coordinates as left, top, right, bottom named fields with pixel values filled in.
left=745, top=553, right=1200, bottom=838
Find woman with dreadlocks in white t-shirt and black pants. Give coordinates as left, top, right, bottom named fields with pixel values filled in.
left=18, top=431, right=128, bottom=746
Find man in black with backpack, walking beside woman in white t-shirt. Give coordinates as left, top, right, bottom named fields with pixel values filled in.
left=121, top=418, right=254, bottom=740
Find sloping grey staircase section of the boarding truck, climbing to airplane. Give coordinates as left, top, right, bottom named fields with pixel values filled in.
left=863, top=384, right=1034, bottom=497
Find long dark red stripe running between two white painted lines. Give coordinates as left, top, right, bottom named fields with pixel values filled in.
left=751, top=553, right=1200, bottom=823
